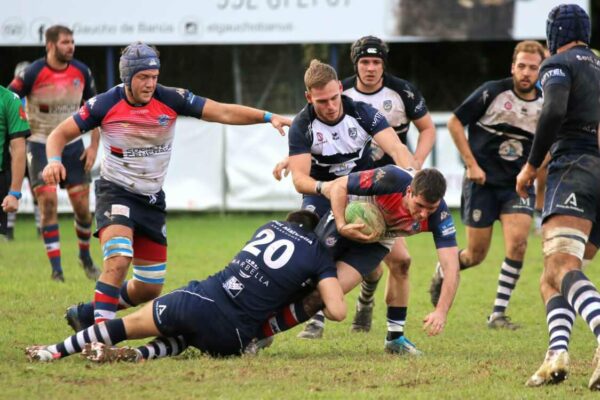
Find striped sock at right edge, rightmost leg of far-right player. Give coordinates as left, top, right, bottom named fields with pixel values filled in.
left=560, top=270, right=600, bottom=344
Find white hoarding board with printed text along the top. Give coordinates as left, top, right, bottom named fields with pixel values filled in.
left=0, top=0, right=589, bottom=46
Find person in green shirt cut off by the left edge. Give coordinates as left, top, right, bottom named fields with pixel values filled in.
left=0, top=86, right=29, bottom=238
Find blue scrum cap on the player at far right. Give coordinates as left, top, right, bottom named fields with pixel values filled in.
left=546, top=4, right=591, bottom=54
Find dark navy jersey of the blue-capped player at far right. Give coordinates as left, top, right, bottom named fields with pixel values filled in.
left=540, top=46, right=600, bottom=158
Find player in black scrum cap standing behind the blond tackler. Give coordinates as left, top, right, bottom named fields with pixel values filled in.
left=298, top=36, right=435, bottom=354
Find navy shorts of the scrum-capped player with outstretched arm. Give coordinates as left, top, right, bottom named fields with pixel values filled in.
left=94, top=178, right=167, bottom=246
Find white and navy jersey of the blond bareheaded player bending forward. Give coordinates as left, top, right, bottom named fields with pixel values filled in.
left=289, top=96, right=389, bottom=181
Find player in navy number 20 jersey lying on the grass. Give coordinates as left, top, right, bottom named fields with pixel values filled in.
left=26, top=210, right=346, bottom=361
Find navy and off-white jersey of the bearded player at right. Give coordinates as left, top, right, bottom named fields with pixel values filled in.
left=454, top=78, right=543, bottom=186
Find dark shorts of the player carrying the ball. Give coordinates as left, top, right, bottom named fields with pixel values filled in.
left=315, top=211, right=389, bottom=276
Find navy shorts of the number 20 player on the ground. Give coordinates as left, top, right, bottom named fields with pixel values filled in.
left=152, top=281, right=252, bottom=357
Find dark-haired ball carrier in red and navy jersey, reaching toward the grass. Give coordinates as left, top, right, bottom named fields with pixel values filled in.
left=259, top=165, right=459, bottom=355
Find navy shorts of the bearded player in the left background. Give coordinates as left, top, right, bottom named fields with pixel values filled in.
left=27, top=140, right=92, bottom=189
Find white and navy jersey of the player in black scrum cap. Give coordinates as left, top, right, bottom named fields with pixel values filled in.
left=342, top=73, right=429, bottom=144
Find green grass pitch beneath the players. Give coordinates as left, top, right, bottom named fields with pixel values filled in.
left=0, top=214, right=600, bottom=400
